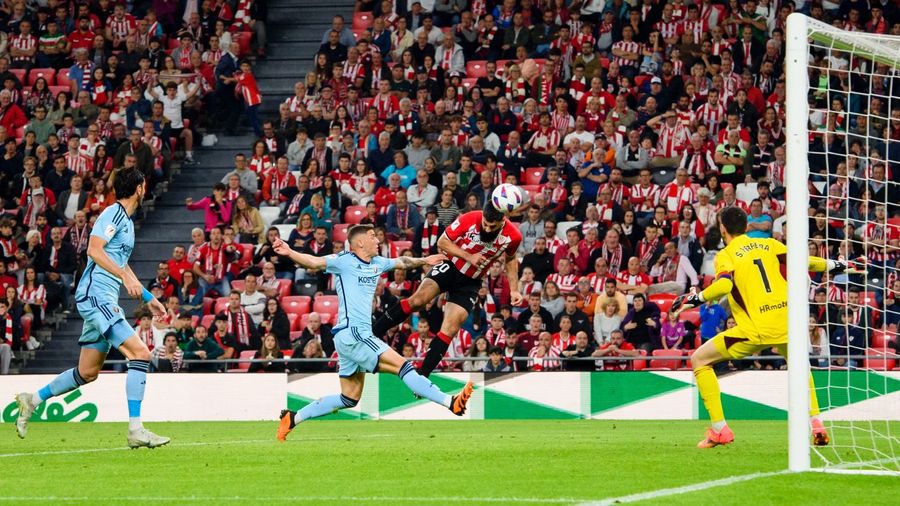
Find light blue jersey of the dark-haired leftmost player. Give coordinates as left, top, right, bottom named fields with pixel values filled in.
left=75, top=202, right=134, bottom=304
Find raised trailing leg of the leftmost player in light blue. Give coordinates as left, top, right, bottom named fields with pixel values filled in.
left=16, top=320, right=109, bottom=438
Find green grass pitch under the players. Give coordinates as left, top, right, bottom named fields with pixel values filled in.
left=0, top=420, right=900, bottom=506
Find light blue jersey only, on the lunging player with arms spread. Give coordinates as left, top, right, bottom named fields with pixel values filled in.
left=325, top=252, right=394, bottom=335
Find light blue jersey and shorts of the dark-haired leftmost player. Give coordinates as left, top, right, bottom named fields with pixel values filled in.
left=75, top=203, right=135, bottom=353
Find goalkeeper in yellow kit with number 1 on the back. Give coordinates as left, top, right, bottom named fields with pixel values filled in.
left=671, top=207, right=847, bottom=448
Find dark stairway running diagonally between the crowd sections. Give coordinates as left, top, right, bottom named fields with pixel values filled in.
left=23, top=0, right=354, bottom=374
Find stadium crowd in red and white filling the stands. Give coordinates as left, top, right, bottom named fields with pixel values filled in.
left=0, top=0, right=900, bottom=372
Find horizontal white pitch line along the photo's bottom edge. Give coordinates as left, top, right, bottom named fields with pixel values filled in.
left=0, top=496, right=579, bottom=504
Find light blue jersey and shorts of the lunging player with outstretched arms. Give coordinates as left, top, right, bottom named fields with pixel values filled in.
left=325, top=252, right=395, bottom=377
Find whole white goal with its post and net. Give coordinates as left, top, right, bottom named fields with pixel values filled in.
left=784, top=14, right=900, bottom=474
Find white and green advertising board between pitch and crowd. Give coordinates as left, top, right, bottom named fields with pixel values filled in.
left=0, top=371, right=900, bottom=423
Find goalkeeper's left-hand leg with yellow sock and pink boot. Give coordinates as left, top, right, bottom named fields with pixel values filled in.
left=691, top=327, right=755, bottom=448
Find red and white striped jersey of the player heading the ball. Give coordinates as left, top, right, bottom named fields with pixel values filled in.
left=444, top=211, right=522, bottom=279
